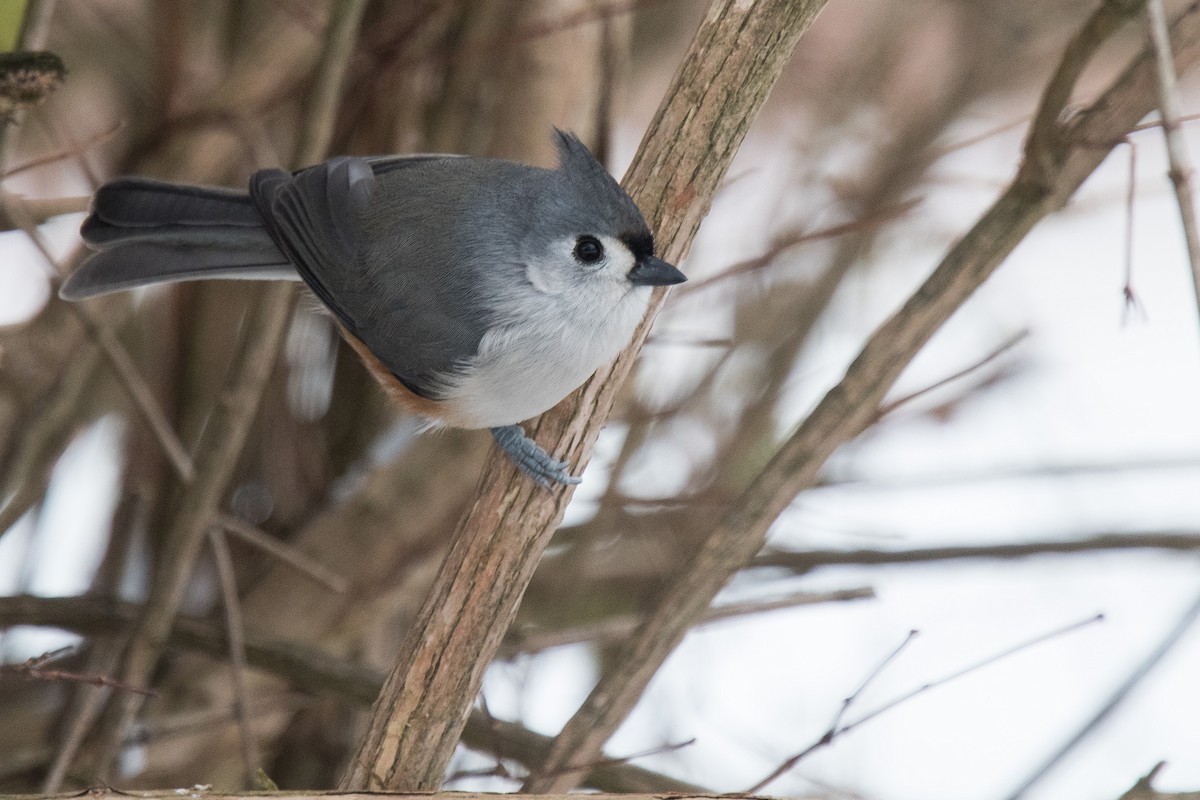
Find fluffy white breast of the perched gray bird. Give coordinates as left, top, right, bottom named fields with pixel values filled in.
left=443, top=284, right=650, bottom=428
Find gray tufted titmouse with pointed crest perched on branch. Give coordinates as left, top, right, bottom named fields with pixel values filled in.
left=59, top=131, right=686, bottom=486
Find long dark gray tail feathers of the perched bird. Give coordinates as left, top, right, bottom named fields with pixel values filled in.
left=59, top=179, right=300, bottom=300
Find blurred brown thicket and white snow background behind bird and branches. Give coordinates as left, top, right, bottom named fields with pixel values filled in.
left=0, top=0, right=1200, bottom=800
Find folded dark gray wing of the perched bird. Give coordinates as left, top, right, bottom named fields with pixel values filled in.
left=250, top=156, right=486, bottom=399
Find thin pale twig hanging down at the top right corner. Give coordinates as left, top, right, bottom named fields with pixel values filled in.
left=1146, top=0, right=1200, bottom=335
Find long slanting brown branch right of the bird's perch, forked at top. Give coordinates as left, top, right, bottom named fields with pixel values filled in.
left=527, top=2, right=1200, bottom=792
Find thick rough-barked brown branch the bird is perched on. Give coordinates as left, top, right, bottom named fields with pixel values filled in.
left=341, top=0, right=823, bottom=789
